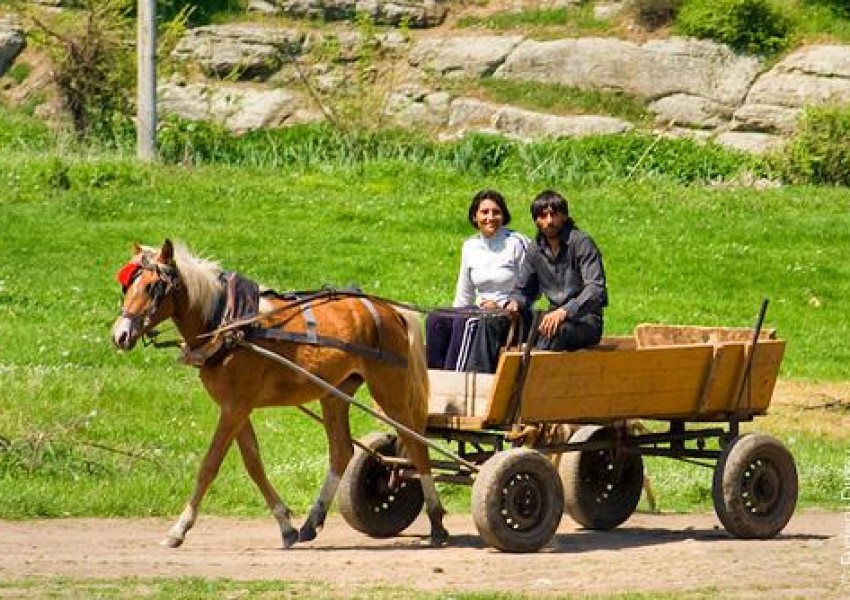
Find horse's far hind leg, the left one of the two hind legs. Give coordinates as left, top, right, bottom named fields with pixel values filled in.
left=298, top=376, right=363, bottom=542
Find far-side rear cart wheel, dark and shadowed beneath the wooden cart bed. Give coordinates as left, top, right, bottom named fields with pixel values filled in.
left=559, top=425, right=643, bottom=530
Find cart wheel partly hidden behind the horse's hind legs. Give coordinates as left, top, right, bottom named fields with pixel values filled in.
left=338, top=432, right=424, bottom=538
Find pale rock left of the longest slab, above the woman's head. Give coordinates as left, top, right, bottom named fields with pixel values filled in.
left=409, top=35, right=522, bottom=77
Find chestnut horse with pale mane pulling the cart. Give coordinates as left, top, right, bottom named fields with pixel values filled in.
left=112, top=240, right=448, bottom=549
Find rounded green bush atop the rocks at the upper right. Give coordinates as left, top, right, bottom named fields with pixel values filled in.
left=676, top=0, right=792, bottom=56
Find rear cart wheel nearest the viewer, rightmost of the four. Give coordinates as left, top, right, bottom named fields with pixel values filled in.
left=711, top=433, right=797, bottom=539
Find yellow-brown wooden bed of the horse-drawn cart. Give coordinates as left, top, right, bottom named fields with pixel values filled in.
left=428, top=325, right=785, bottom=430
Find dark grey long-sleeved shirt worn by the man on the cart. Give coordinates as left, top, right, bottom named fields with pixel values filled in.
left=511, top=225, right=608, bottom=320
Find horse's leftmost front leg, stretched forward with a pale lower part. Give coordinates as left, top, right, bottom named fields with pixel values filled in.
left=162, top=410, right=247, bottom=548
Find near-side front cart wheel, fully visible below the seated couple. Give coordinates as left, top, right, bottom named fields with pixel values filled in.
left=472, top=448, right=564, bottom=552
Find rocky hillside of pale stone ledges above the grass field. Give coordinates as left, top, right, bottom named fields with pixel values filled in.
left=0, top=0, right=850, bottom=152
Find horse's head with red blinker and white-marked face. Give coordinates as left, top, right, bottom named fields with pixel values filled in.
left=112, top=240, right=179, bottom=350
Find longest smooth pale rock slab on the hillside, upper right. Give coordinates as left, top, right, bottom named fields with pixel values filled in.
left=496, top=38, right=762, bottom=107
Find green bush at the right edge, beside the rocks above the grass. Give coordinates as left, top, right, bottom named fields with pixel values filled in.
left=774, top=106, right=850, bottom=186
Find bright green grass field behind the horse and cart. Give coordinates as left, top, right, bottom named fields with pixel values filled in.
left=0, top=143, right=850, bottom=518
